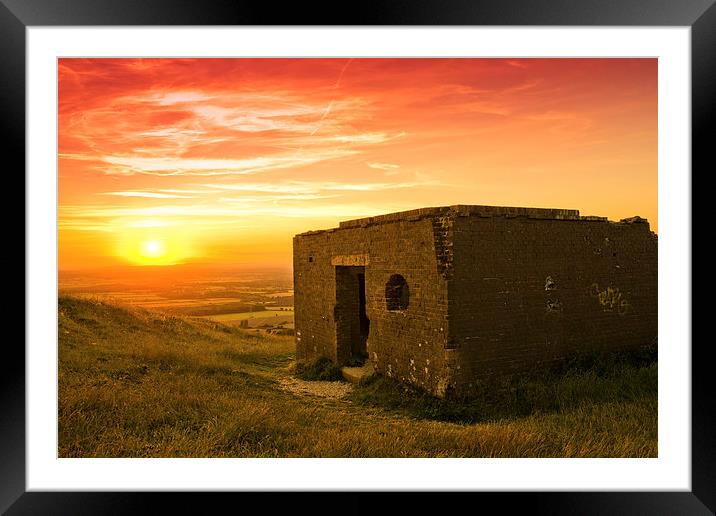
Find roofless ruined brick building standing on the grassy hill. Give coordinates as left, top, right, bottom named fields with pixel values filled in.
left=293, top=205, right=657, bottom=396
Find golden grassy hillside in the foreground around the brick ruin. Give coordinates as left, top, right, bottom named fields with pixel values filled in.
left=58, top=297, right=657, bottom=457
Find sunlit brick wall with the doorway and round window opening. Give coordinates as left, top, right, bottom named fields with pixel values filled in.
left=293, top=217, right=447, bottom=391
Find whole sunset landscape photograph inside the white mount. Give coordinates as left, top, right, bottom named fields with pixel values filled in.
left=58, top=56, right=656, bottom=459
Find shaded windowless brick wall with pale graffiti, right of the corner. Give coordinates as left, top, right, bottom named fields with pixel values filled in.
left=449, top=212, right=657, bottom=387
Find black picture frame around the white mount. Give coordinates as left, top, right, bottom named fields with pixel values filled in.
left=0, top=0, right=716, bottom=514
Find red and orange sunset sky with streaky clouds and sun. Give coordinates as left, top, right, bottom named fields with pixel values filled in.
left=58, top=58, right=658, bottom=270
